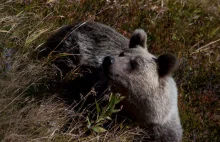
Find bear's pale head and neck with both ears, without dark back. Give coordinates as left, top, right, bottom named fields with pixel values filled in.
left=102, top=29, right=183, bottom=142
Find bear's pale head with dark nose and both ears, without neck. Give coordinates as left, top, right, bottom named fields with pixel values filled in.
left=102, top=29, right=177, bottom=93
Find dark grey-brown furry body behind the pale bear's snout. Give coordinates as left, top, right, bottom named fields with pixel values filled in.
left=38, top=21, right=129, bottom=103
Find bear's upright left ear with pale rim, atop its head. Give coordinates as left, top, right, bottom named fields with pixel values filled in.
left=129, top=29, right=147, bottom=48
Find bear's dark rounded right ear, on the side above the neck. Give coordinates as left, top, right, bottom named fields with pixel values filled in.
left=157, top=53, right=178, bottom=77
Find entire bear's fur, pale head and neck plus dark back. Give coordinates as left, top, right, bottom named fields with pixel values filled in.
left=39, top=22, right=182, bottom=142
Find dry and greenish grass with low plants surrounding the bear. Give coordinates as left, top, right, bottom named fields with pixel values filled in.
left=0, top=0, right=220, bottom=142
